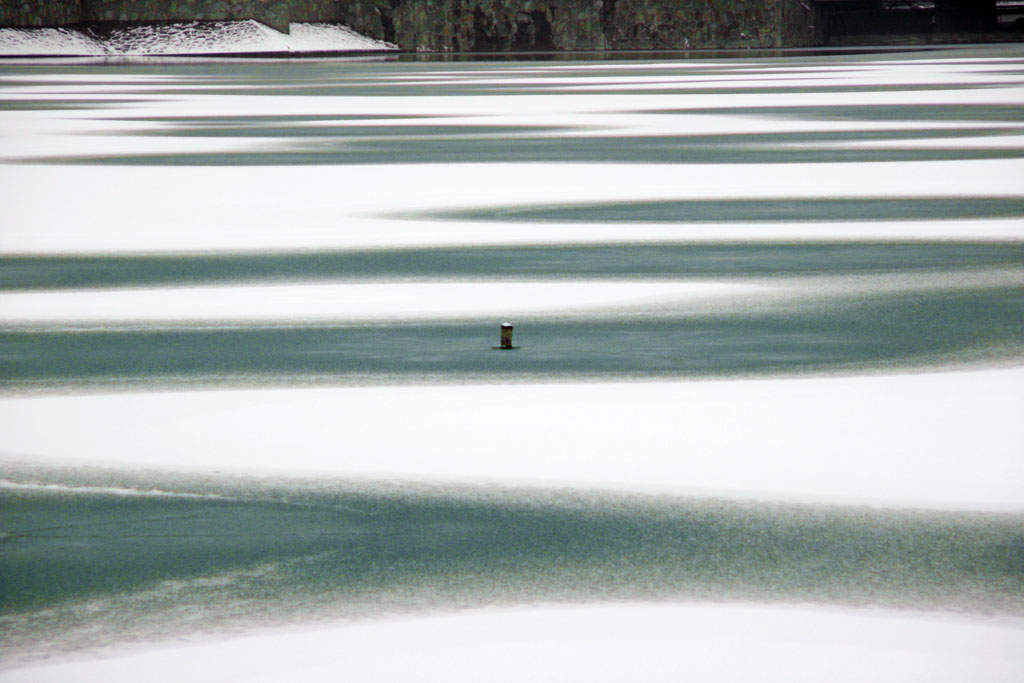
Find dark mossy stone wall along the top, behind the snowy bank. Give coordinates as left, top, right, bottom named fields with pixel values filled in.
left=0, top=0, right=815, bottom=47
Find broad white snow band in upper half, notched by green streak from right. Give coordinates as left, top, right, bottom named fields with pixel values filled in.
left=0, top=162, right=1024, bottom=254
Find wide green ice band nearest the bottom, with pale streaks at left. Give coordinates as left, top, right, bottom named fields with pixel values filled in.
left=0, top=466, right=1024, bottom=656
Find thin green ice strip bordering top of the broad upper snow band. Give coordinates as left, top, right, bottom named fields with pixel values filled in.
left=16, top=130, right=1024, bottom=167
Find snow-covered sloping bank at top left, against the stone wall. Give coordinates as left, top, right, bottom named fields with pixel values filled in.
left=0, top=19, right=396, bottom=56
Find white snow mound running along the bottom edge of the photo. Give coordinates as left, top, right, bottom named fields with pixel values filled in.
left=0, top=604, right=1024, bottom=683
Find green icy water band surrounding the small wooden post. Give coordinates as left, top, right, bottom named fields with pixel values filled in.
left=0, top=288, right=1024, bottom=388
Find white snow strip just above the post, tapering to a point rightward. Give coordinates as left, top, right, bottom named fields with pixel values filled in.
left=0, top=280, right=765, bottom=327
